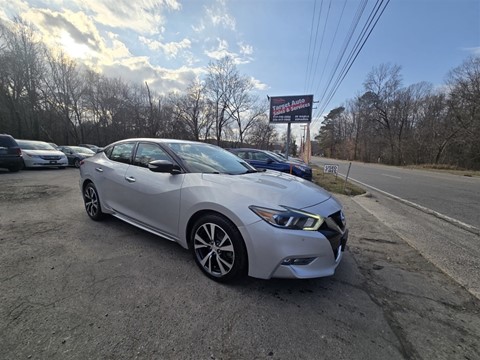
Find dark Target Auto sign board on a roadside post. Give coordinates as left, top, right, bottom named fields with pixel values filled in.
left=270, top=95, right=313, bottom=123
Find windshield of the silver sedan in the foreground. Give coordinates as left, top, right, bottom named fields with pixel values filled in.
left=166, top=142, right=256, bottom=175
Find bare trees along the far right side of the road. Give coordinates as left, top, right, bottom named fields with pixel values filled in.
left=316, top=59, right=480, bottom=170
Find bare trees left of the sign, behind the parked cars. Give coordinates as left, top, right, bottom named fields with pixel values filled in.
left=0, top=19, right=278, bottom=148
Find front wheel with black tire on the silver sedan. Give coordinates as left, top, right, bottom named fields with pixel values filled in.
left=190, top=214, right=248, bottom=282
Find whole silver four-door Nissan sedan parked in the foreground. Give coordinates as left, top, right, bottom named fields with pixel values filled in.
left=80, top=139, right=348, bottom=281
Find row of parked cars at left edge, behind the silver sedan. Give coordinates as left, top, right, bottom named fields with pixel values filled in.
left=0, top=134, right=101, bottom=172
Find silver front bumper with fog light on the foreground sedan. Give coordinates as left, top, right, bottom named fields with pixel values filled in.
left=240, top=220, right=348, bottom=279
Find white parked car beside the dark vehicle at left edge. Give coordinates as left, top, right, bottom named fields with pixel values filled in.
left=17, top=139, right=68, bottom=169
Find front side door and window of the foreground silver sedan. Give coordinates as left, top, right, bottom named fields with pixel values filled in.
left=124, top=142, right=185, bottom=239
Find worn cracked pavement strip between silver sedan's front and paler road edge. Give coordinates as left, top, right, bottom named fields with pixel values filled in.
left=337, top=195, right=480, bottom=359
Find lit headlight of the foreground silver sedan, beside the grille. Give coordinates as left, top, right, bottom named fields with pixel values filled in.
left=249, top=205, right=324, bottom=231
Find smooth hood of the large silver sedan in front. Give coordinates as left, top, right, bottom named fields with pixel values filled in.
left=202, top=171, right=332, bottom=209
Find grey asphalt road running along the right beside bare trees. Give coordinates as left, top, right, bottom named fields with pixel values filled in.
left=312, top=157, right=480, bottom=229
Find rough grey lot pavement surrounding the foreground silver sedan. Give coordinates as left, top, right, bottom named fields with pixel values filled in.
left=0, top=168, right=480, bottom=359
